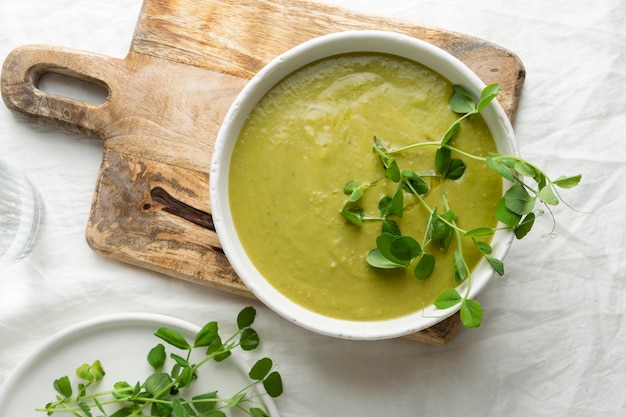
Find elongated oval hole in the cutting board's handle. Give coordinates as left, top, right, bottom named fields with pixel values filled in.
left=37, top=72, right=109, bottom=105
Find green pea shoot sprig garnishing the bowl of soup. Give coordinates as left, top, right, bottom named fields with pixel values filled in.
left=340, top=84, right=581, bottom=328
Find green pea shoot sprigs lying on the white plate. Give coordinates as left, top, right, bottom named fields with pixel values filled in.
left=36, top=307, right=283, bottom=417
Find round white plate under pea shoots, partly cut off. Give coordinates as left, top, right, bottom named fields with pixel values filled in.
left=0, top=313, right=278, bottom=417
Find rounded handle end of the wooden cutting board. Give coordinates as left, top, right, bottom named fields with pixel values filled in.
left=1, top=45, right=122, bottom=137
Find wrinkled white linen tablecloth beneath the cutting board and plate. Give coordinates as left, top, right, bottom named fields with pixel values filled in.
left=0, top=0, right=626, bottom=417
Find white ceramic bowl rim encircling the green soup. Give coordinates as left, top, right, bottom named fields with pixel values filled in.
left=210, top=31, right=517, bottom=340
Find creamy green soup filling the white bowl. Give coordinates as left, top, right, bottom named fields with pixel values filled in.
left=229, top=54, right=502, bottom=321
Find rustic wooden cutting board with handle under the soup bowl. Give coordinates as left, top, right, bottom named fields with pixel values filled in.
left=1, top=0, right=525, bottom=344
